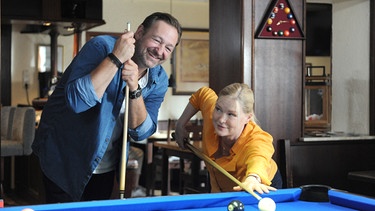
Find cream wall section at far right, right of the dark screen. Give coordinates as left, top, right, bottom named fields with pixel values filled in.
left=332, top=0, right=370, bottom=134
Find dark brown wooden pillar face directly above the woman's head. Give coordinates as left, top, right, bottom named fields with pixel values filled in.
left=209, top=0, right=243, bottom=91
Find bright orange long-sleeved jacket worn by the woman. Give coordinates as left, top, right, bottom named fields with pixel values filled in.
left=189, top=87, right=277, bottom=192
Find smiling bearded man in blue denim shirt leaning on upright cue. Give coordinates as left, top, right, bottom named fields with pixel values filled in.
left=33, top=12, right=181, bottom=203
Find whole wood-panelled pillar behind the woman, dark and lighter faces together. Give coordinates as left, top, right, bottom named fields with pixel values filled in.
left=209, top=0, right=305, bottom=164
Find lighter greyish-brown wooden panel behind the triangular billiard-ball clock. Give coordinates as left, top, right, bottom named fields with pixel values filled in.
left=253, top=0, right=304, bottom=141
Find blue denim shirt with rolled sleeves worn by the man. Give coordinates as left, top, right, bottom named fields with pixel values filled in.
left=32, top=36, right=168, bottom=201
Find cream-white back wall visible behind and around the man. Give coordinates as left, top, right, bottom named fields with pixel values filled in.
left=12, top=0, right=209, bottom=120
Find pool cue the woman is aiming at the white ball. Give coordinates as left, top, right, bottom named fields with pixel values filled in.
left=185, top=141, right=262, bottom=200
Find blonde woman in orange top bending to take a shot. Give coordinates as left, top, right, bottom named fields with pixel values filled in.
left=175, top=83, right=282, bottom=194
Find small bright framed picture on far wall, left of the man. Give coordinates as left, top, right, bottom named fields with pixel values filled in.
left=37, top=45, right=64, bottom=73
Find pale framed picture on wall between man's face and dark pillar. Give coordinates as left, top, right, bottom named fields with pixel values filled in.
left=170, top=29, right=209, bottom=95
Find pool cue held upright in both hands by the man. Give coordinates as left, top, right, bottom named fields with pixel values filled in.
left=119, top=22, right=130, bottom=199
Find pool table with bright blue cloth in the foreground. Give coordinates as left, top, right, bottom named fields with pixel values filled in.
left=0, top=188, right=375, bottom=211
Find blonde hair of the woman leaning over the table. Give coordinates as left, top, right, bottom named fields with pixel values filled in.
left=219, top=83, right=256, bottom=122
